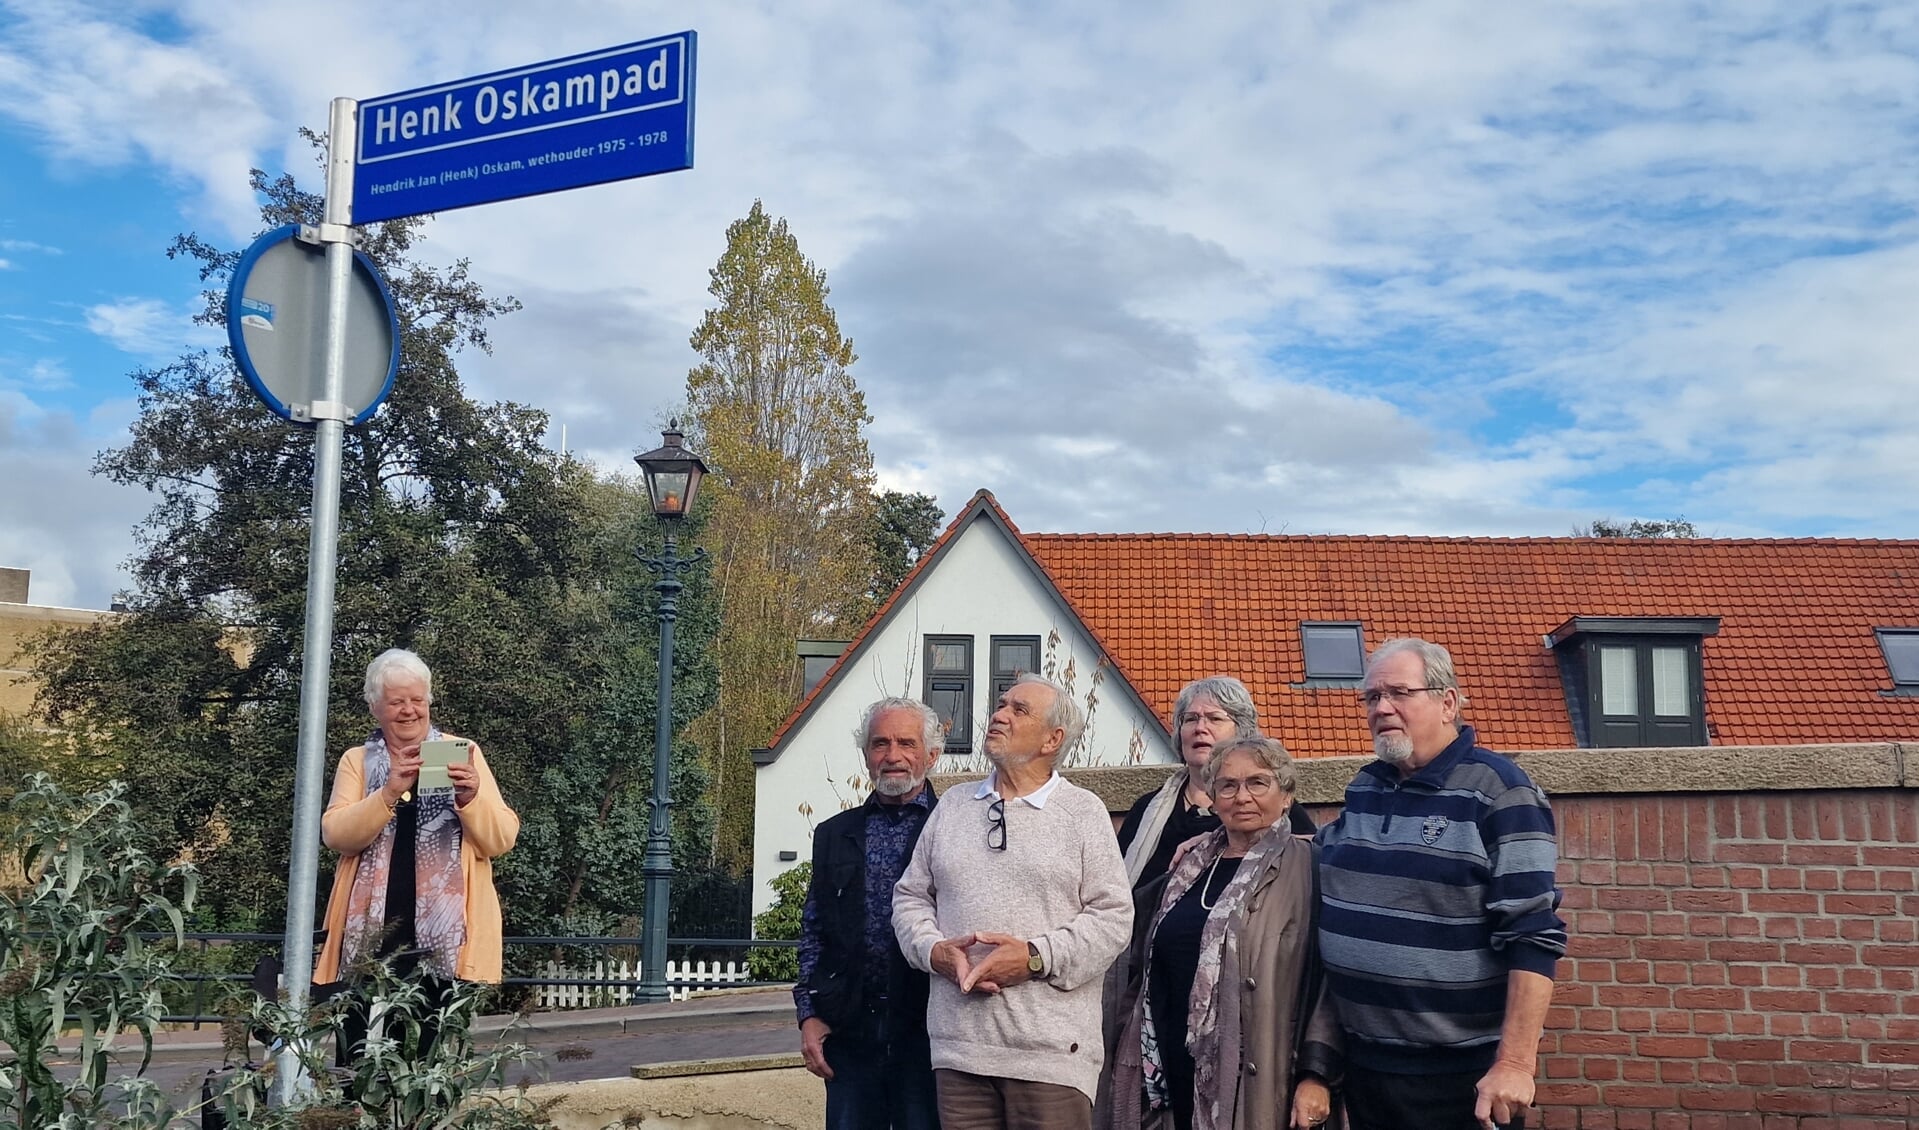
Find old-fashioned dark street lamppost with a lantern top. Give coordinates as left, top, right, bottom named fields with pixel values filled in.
left=633, top=420, right=706, bottom=1003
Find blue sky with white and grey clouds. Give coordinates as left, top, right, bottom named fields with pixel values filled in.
left=0, top=0, right=1919, bottom=606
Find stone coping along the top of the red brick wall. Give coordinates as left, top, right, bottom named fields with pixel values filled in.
left=933, top=742, right=1919, bottom=812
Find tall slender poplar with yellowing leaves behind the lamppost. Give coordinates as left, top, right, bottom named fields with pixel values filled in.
left=687, top=201, right=873, bottom=871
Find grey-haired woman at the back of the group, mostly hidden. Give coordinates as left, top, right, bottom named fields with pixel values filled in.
left=1119, top=675, right=1315, bottom=888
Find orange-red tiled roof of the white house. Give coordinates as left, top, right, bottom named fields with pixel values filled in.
left=1023, top=533, right=1919, bottom=756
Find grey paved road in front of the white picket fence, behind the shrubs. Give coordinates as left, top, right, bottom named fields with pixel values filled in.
left=58, top=990, right=800, bottom=1105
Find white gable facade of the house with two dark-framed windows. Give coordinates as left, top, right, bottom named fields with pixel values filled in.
left=752, top=491, right=1174, bottom=913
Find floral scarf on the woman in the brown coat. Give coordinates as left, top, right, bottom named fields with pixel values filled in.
left=1140, top=813, right=1290, bottom=1130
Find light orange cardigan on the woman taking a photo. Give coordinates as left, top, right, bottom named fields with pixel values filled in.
left=313, top=733, right=520, bottom=984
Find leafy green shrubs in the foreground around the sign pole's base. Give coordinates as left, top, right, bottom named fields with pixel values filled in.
left=0, top=773, right=553, bottom=1130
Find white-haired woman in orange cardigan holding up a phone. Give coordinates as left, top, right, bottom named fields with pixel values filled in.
left=313, top=648, right=520, bottom=989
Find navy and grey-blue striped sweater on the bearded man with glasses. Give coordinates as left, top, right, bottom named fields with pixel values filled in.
left=1318, top=725, right=1566, bottom=1074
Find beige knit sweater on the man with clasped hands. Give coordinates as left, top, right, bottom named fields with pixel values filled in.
left=892, top=781, right=1132, bottom=1099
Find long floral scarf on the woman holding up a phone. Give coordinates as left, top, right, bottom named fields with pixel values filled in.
left=340, top=727, right=466, bottom=978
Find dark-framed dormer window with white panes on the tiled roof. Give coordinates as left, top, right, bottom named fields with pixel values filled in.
left=1545, top=616, right=1719, bottom=748
